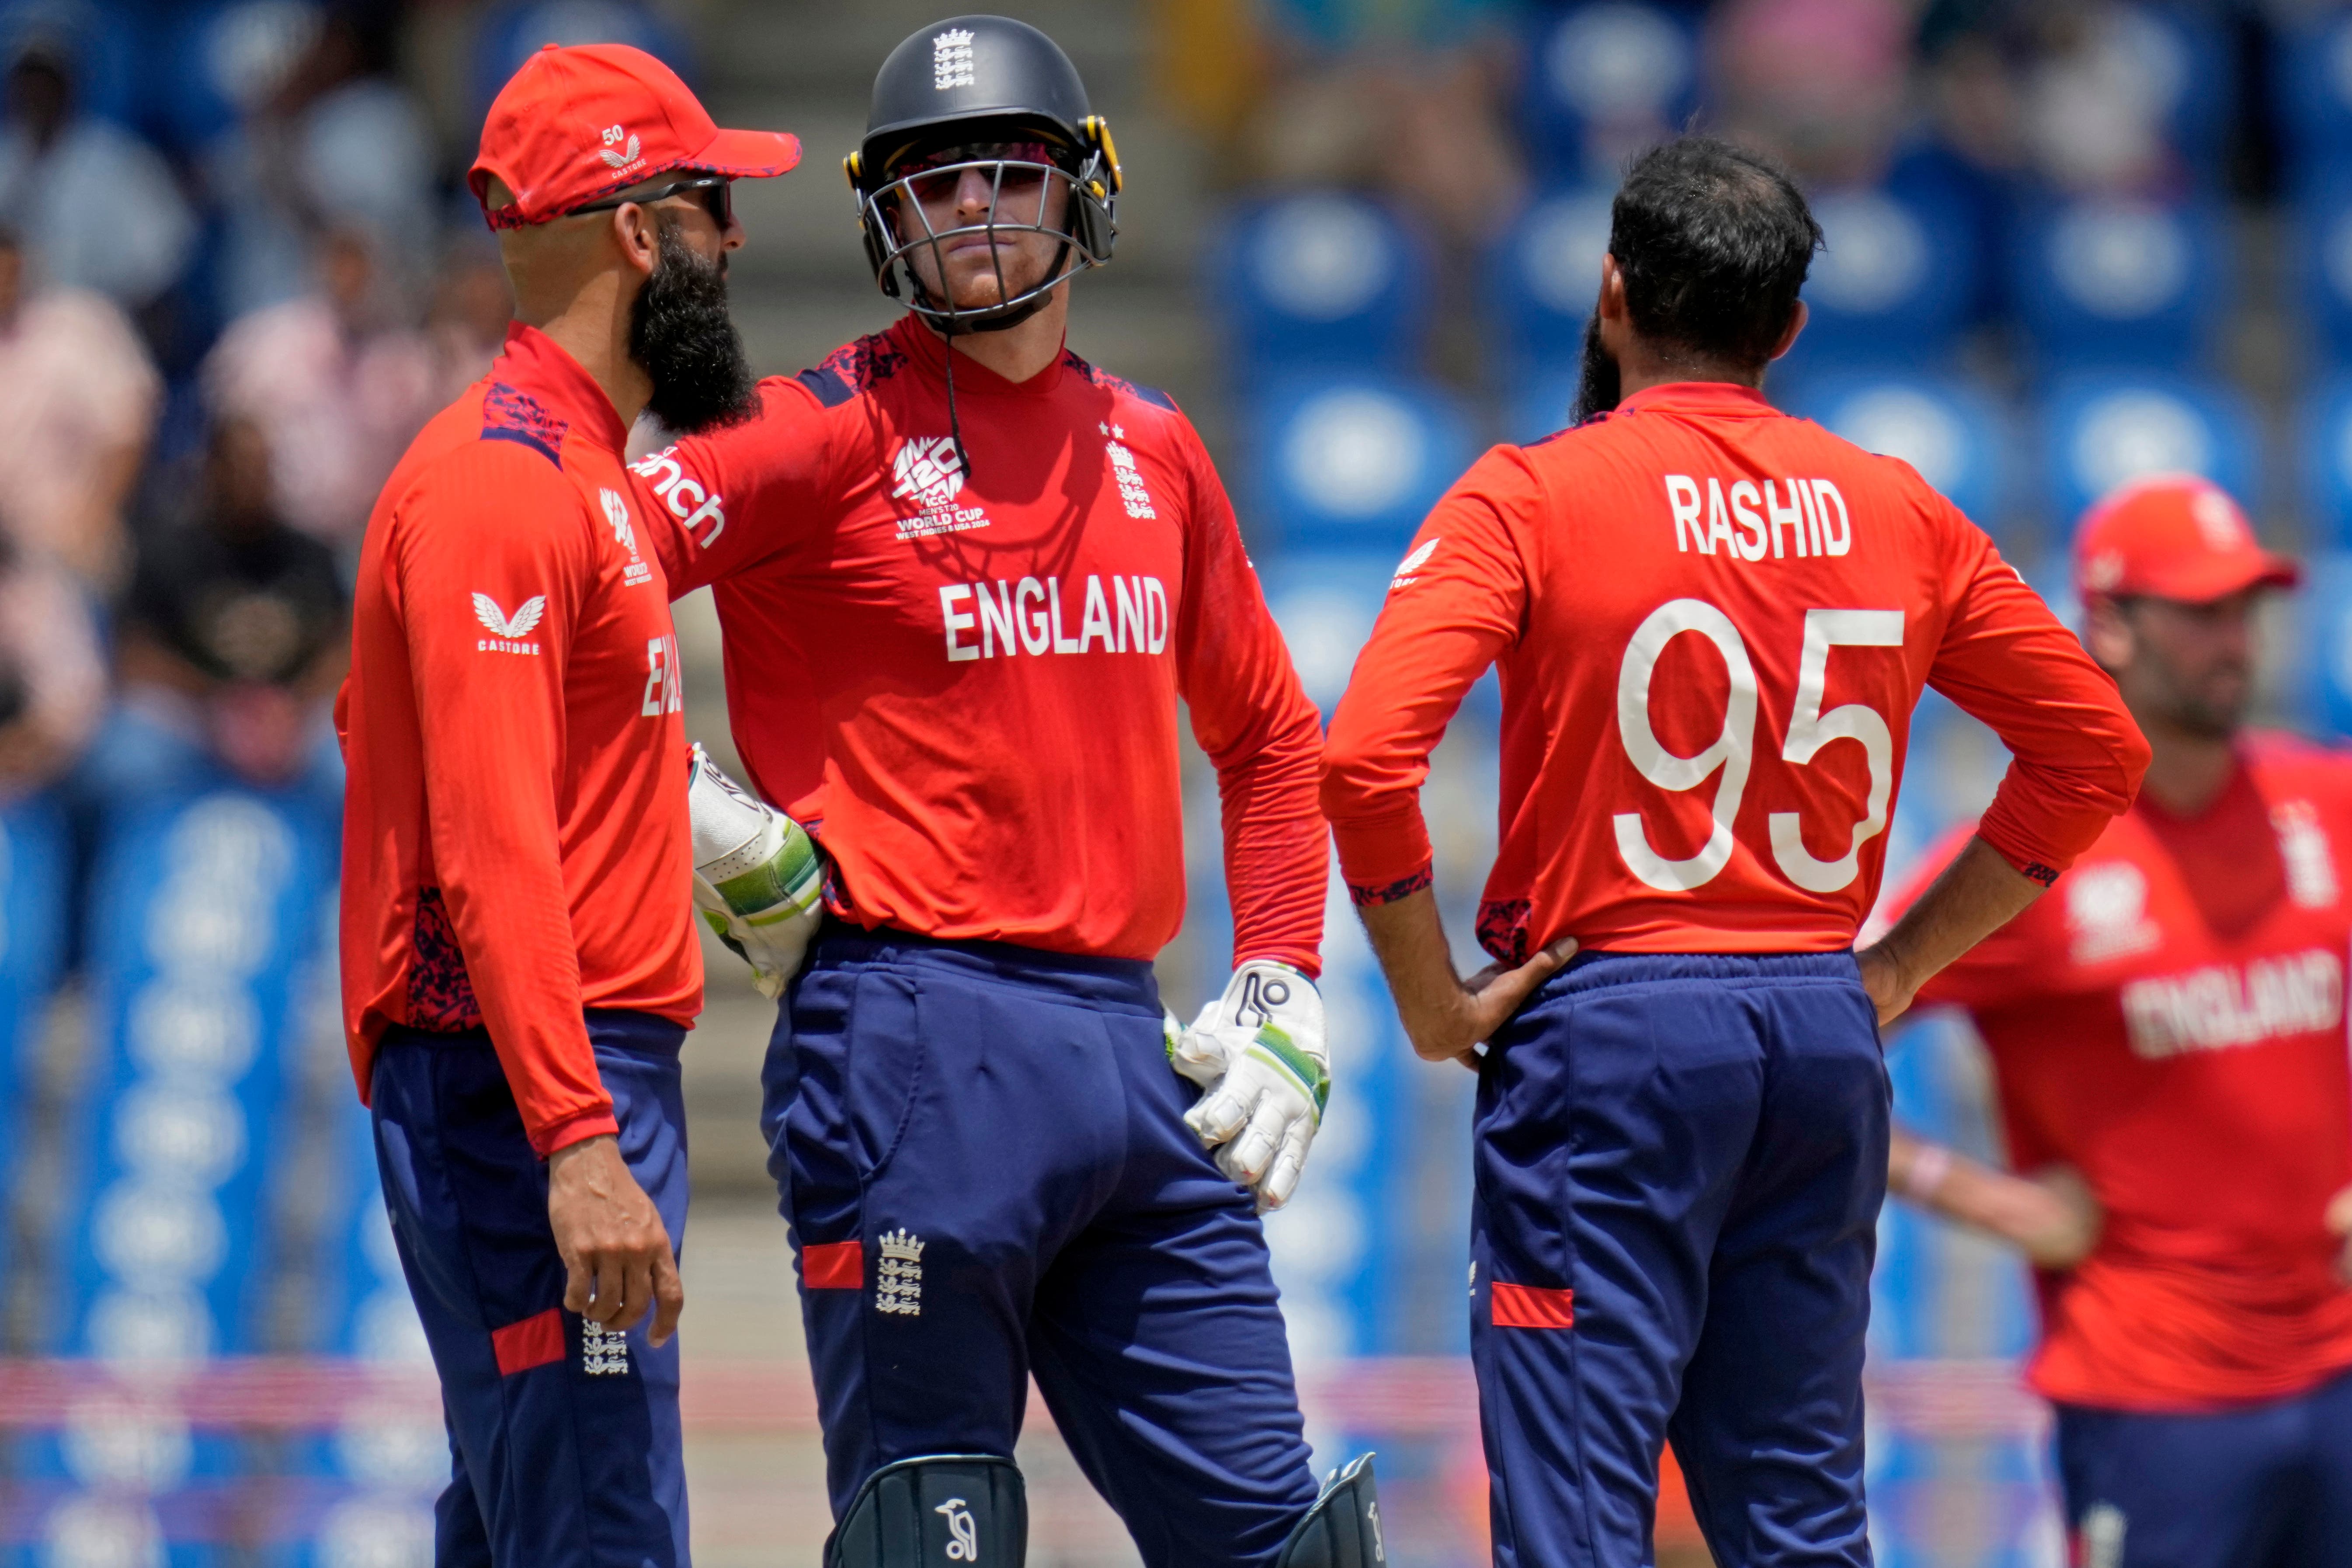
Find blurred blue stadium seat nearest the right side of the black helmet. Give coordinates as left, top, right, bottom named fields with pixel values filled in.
left=1214, top=191, right=1430, bottom=385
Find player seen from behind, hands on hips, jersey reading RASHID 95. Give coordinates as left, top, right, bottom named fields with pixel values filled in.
left=1324, top=136, right=2147, bottom=1568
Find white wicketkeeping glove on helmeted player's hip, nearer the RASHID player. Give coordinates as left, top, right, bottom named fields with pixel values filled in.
left=1169, top=959, right=1331, bottom=1211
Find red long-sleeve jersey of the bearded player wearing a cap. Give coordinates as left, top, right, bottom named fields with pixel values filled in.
left=336, top=327, right=703, bottom=1154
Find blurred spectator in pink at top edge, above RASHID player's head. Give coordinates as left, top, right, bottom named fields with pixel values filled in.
left=1710, top=0, right=1912, bottom=186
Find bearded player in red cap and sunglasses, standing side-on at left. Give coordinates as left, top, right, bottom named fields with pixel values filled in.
left=336, top=45, right=800, bottom=1568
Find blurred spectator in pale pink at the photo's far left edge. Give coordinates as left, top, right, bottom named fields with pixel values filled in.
left=0, top=228, right=162, bottom=590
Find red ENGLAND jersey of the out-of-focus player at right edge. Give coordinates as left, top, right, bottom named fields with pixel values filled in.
left=1896, top=736, right=2352, bottom=1411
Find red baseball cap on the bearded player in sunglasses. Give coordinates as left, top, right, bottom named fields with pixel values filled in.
left=466, top=45, right=800, bottom=228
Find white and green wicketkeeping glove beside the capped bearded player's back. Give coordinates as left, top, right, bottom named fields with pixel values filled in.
left=687, top=745, right=826, bottom=1002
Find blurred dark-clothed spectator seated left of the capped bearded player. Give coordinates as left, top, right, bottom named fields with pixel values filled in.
left=94, top=419, right=351, bottom=799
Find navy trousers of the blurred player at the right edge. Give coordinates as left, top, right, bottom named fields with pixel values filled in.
left=2058, top=1373, right=2352, bottom=1568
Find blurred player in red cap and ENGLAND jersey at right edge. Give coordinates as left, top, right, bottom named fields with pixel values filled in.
left=1889, top=477, right=2352, bottom=1568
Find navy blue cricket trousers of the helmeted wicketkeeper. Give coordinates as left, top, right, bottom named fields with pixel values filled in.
left=764, top=929, right=1315, bottom=1568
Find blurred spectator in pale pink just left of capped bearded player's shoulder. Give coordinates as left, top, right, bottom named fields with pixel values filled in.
left=202, top=228, right=445, bottom=550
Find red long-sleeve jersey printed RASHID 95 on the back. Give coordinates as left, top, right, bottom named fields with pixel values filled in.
left=1322, top=383, right=2147, bottom=959
